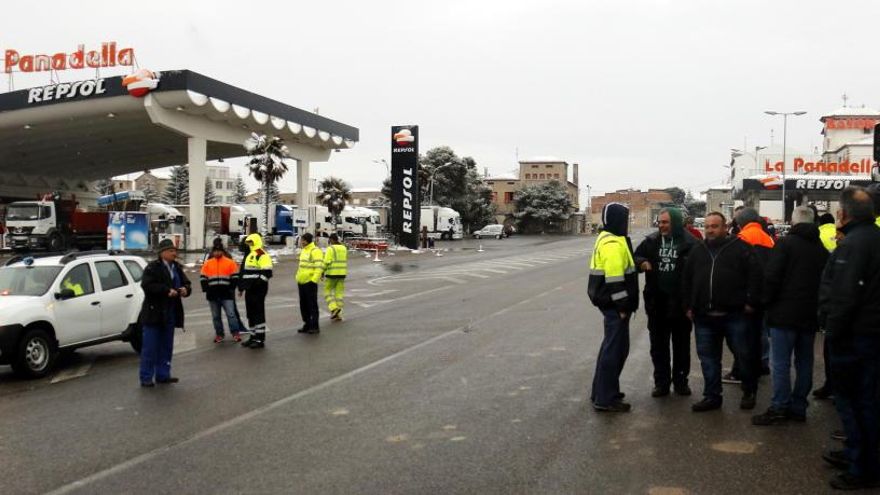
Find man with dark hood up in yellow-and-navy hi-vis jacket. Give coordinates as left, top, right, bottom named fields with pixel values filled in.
left=587, top=203, right=639, bottom=412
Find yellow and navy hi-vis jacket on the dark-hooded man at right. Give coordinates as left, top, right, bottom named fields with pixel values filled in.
left=587, top=231, right=639, bottom=312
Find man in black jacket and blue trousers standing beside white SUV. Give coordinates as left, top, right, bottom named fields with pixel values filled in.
left=139, top=239, right=192, bottom=387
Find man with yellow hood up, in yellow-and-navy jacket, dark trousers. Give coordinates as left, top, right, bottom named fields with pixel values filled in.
left=238, top=233, right=272, bottom=349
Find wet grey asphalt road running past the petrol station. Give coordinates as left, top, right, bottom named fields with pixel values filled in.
left=0, top=237, right=868, bottom=495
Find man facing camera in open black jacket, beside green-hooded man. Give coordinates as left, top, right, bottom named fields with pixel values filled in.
left=683, top=212, right=761, bottom=412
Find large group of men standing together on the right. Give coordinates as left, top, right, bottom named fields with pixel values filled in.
left=588, top=187, right=880, bottom=489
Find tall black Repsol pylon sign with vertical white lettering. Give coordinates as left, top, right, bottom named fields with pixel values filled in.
left=391, top=125, right=421, bottom=249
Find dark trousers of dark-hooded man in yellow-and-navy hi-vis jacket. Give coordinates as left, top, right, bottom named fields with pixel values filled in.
left=590, top=309, right=630, bottom=406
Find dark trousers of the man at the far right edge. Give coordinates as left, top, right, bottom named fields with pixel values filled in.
left=829, top=335, right=880, bottom=479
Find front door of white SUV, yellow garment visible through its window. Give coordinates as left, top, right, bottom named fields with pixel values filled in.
left=52, top=261, right=101, bottom=347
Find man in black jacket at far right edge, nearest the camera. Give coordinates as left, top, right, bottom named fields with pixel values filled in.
left=819, top=187, right=880, bottom=489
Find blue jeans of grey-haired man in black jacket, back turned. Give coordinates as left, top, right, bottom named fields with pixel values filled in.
left=770, top=328, right=816, bottom=416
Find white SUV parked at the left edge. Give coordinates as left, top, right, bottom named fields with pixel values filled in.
left=0, top=251, right=146, bottom=378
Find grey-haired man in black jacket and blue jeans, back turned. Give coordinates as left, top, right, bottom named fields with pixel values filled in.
left=752, top=206, right=828, bottom=426
